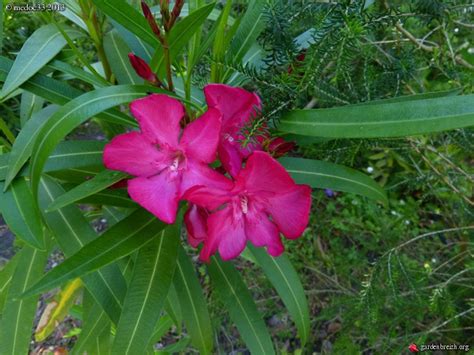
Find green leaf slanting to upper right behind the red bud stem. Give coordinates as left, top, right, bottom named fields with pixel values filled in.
left=150, top=3, right=215, bottom=76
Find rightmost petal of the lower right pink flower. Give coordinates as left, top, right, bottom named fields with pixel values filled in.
left=266, top=185, right=311, bottom=239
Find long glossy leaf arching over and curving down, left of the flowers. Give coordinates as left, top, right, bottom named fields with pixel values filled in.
left=30, top=85, right=157, bottom=195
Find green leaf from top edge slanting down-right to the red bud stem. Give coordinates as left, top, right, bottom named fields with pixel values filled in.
left=92, top=0, right=160, bottom=48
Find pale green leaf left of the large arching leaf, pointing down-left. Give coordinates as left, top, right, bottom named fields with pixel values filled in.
left=5, top=105, right=58, bottom=188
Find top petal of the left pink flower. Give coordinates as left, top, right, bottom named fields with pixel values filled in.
left=130, top=94, right=184, bottom=148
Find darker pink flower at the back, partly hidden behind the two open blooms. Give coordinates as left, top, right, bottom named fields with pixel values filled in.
left=204, top=84, right=262, bottom=177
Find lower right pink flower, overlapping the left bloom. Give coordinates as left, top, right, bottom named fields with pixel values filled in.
left=183, top=152, right=311, bottom=262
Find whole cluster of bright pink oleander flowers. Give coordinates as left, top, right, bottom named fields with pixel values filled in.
left=104, top=84, right=311, bottom=262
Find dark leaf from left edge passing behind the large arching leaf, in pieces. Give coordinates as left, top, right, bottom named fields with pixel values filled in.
left=0, top=56, right=137, bottom=126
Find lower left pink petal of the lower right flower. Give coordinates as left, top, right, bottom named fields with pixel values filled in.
left=200, top=206, right=247, bottom=262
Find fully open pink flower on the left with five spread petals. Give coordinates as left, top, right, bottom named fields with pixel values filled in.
left=104, top=94, right=232, bottom=223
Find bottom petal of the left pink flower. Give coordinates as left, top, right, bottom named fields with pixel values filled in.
left=128, top=170, right=180, bottom=224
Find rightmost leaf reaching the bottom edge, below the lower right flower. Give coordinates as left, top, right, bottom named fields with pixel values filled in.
left=209, top=257, right=275, bottom=354
